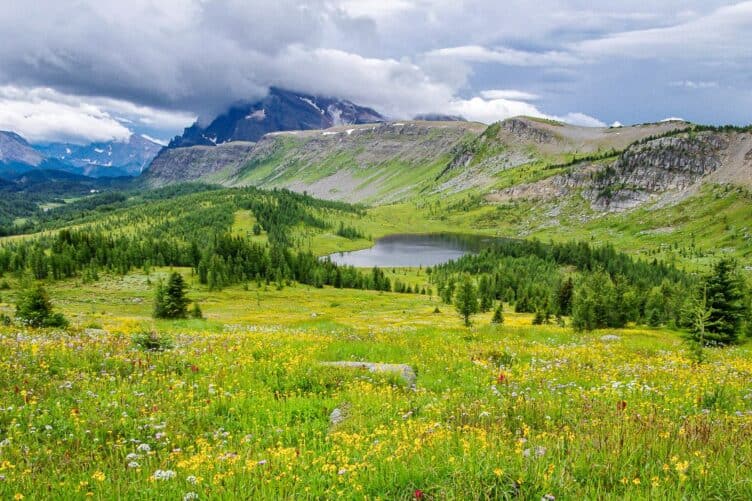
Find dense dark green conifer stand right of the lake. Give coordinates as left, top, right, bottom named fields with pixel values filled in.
left=431, top=240, right=695, bottom=329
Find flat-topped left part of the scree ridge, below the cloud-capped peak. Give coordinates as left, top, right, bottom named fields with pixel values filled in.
left=143, top=122, right=485, bottom=202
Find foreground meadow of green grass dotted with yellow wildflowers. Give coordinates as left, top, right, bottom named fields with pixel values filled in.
left=0, top=270, right=752, bottom=500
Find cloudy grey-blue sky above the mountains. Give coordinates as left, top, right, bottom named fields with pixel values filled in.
left=0, top=0, right=752, bottom=144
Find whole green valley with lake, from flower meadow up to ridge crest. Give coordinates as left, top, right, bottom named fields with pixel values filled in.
left=0, top=100, right=752, bottom=499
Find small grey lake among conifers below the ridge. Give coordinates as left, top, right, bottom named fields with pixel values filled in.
left=329, top=233, right=493, bottom=268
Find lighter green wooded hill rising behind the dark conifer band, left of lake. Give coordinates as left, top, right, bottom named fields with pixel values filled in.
left=0, top=183, right=364, bottom=242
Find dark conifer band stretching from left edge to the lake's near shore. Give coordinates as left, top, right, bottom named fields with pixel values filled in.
left=0, top=230, right=406, bottom=291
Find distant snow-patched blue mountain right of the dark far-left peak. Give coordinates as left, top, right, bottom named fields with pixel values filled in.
left=38, top=134, right=162, bottom=177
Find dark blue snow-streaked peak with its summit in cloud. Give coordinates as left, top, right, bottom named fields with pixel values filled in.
left=169, top=87, right=384, bottom=148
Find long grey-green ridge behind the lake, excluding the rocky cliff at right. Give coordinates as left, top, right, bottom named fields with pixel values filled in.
left=144, top=117, right=700, bottom=203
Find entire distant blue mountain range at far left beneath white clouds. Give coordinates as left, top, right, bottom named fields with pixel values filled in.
left=0, top=131, right=162, bottom=179
